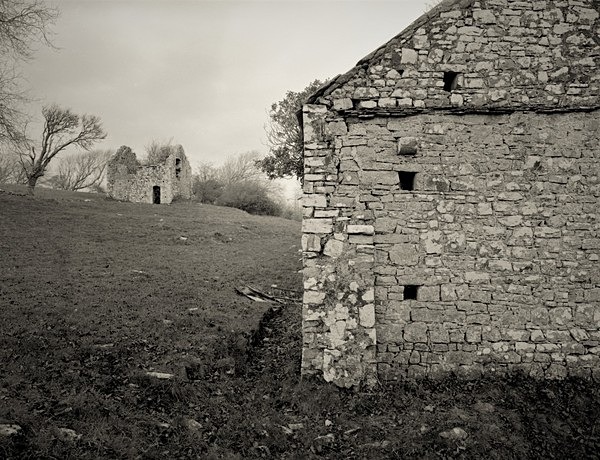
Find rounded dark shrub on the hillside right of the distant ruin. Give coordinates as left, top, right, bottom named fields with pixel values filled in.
left=215, top=181, right=281, bottom=216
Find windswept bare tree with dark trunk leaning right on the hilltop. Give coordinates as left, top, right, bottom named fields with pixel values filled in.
left=19, top=104, right=106, bottom=195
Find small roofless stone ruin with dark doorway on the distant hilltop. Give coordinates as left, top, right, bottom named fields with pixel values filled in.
left=106, top=145, right=192, bottom=204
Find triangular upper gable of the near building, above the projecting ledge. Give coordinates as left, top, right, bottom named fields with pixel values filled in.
left=322, top=0, right=600, bottom=113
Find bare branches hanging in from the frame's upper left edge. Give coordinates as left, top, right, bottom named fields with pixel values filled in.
left=0, top=0, right=58, bottom=143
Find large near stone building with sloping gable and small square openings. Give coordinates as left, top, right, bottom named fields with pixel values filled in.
left=302, top=0, right=600, bottom=387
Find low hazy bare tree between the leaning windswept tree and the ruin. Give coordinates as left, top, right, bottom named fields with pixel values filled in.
left=49, top=150, right=112, bottom=191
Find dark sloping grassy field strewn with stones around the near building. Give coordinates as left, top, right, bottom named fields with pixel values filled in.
left=0, top=186, right=600, bottom=459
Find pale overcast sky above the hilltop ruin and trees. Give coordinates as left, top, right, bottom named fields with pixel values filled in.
left=24, top=0, right=432, bottom=171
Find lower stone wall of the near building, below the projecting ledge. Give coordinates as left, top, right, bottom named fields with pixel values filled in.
left=303, top=106, right=600, bottom=386
